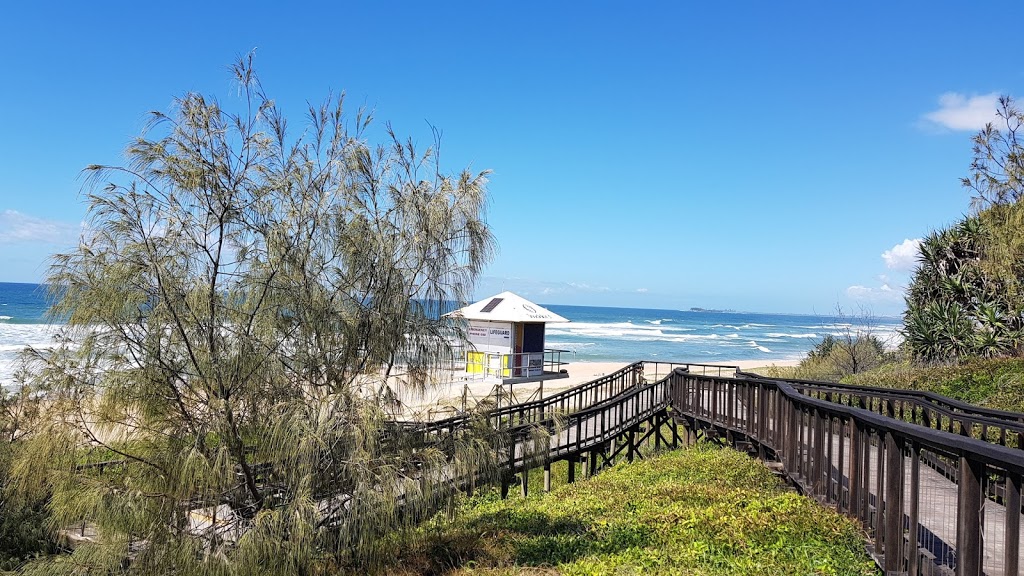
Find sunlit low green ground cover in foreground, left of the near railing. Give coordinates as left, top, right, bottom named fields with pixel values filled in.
left=383, top=446, right=878, bottom=575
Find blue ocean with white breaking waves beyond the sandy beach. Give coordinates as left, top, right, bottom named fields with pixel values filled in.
left=0, top=282, right=901, bottom=385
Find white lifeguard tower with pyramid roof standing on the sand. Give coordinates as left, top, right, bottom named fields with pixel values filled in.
left=447, top=292, right=568, bottom=384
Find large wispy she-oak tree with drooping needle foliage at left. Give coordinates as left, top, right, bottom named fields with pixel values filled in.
left=13, top=57, right=497, bottom=574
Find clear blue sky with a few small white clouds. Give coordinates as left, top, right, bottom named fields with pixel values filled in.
left=0, top=2, right=1024, bottom=314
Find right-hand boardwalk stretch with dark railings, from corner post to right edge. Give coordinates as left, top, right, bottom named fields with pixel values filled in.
left=669, top=372, right=1024, bottom=576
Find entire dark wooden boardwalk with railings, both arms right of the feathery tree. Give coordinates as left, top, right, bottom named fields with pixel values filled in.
left=466, top=363, right=1024, bottom=576
